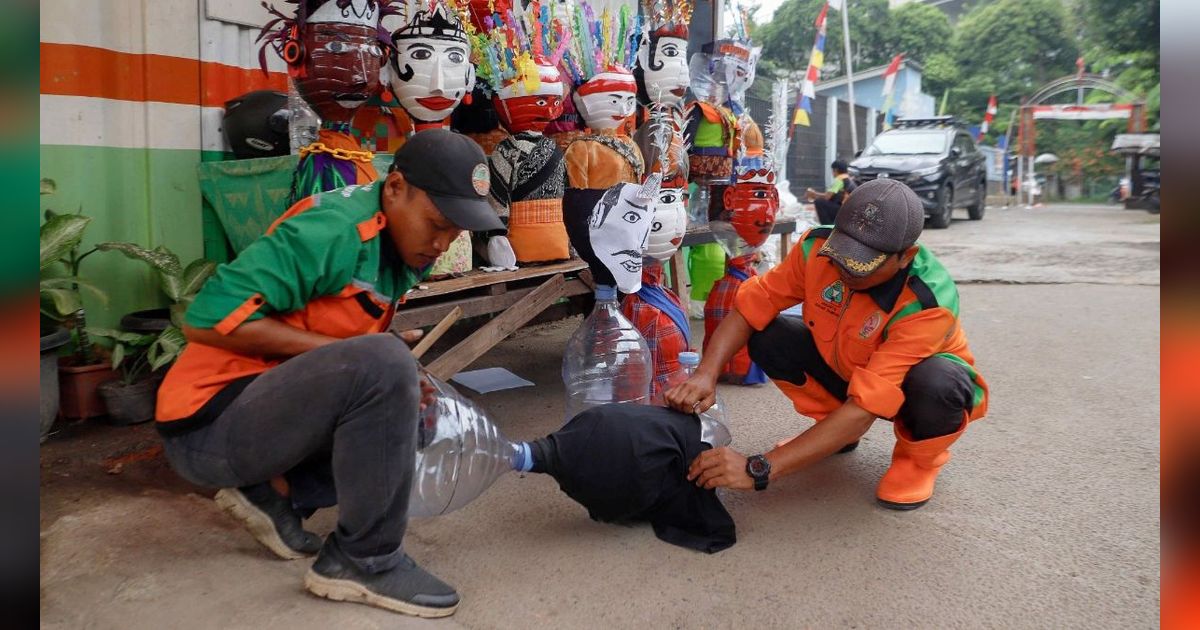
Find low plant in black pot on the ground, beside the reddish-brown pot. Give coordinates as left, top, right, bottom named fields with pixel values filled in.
left=90, top=326, right=186, bottom=425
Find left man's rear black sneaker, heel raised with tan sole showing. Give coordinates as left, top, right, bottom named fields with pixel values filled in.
left=214, top=484, right=320, bottom=560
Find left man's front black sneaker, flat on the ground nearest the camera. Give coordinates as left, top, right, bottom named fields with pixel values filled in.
left=304, top=534, right=458, bottom=618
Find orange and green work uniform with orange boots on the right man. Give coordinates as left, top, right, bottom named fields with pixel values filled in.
left=734, top=227, right=988, bottom=506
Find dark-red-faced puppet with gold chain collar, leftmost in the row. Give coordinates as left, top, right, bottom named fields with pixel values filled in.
left=258, top=0, right=397, bottom=203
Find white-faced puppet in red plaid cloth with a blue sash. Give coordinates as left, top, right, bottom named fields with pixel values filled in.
left=620, top=103, right=691, bottom=404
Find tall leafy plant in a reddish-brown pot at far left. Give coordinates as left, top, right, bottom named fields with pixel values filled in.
left=38, top=179, right=113, bottom=429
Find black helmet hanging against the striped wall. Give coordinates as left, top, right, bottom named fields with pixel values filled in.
left=222, top=90, right=290, bottom=160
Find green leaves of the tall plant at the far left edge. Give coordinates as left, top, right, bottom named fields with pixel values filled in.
left=38, top=179, right=108, bottom=365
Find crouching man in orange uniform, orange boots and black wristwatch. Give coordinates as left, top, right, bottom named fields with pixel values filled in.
left=666, top=175, right=988, bottom=510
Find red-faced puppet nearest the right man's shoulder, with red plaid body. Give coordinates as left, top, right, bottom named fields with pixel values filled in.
left=704, top=114, right=786, bottom=385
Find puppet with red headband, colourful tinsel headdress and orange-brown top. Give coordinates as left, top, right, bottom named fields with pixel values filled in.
left=563, top=0, right=646, bottom=230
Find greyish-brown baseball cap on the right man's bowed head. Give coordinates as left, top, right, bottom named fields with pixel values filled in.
left=817, top=179, right=925, bottom=277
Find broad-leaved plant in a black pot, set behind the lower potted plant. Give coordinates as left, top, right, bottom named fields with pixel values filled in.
left=96, top=242, right=217, bottom=332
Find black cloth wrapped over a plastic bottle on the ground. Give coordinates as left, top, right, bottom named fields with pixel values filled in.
left=533, top=403, right=737, bottom=553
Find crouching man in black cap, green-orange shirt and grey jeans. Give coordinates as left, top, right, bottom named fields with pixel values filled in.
left=157, top=130, right=503, bottom=617
